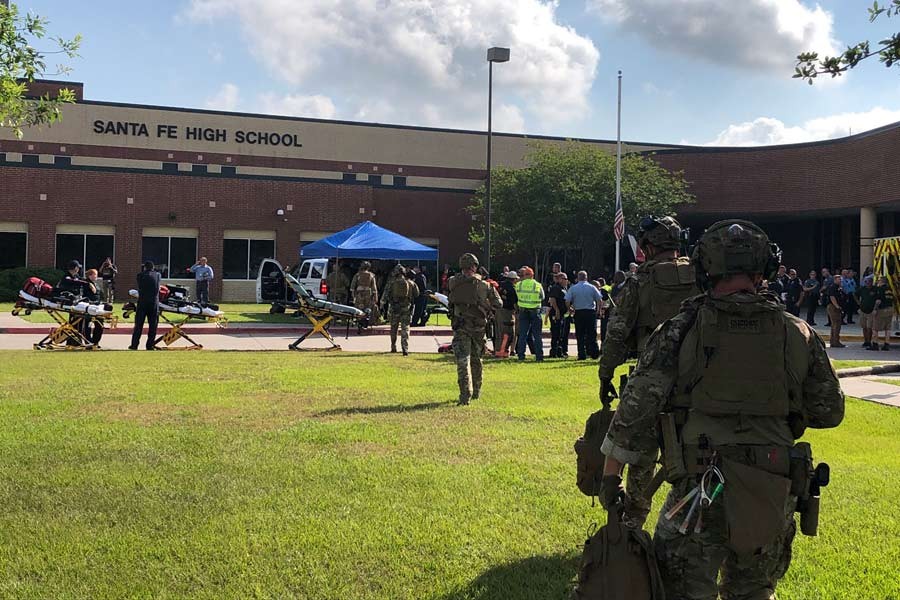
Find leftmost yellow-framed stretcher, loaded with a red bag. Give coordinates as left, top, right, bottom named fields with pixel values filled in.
left=12, top=277, right=118, bottom=350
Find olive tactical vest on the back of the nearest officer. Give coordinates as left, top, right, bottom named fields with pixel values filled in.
left=673, top=298, right=809, bottom=442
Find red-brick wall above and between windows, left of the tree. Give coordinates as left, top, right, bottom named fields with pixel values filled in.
left=0, top=165, right=471, bottom=299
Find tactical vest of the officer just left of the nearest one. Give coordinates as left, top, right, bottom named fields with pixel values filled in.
left=635, top=257, right=699, bottom=352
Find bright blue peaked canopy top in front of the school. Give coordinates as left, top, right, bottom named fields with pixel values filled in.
left=300, top=221, right=438, bottom=261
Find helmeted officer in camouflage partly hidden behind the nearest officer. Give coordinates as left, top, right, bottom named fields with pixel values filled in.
left=599, top=217, right=699, bottom=525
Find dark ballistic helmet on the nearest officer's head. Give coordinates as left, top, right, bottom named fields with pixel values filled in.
left=691, top=219, right=781, bottom=287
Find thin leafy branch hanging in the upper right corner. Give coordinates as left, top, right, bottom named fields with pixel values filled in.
left=794, top=0, right=900, bottom=85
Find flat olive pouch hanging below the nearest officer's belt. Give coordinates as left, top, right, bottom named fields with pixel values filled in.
left=721, top=458, right=791, bottom=556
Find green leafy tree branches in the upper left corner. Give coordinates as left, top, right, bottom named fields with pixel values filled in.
left=0, top=3, right=81, bottom=139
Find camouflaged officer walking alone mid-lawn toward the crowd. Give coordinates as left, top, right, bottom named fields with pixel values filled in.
left=447, top=254, right=503, bottom=405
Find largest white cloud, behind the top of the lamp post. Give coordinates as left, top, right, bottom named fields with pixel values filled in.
left=184, top=0, right=600, bottom=131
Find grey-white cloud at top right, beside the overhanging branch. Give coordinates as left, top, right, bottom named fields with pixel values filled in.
left=588, top=0, right=840, bottom=72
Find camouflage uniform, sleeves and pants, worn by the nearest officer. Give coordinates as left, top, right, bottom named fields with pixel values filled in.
left=602, top=221, right=844, bottom=600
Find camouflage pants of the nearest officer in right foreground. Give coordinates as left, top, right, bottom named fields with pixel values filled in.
left=653, top=478, right=797, bottom=600
